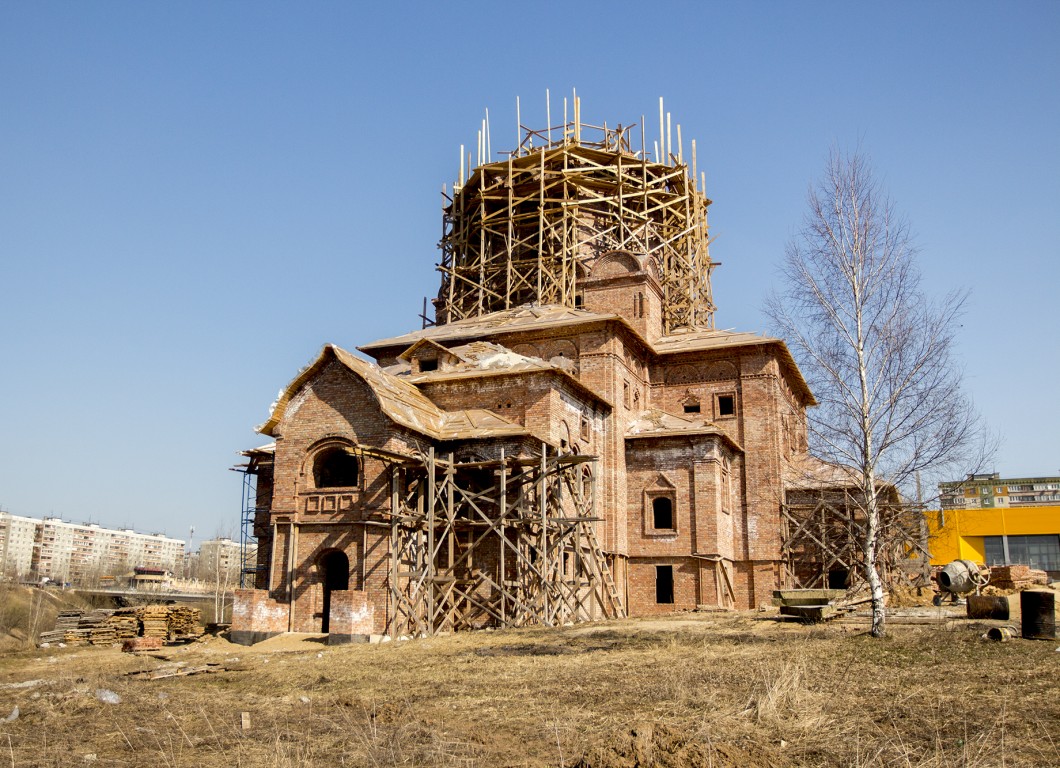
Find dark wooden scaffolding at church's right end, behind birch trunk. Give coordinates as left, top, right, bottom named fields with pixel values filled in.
left=781, top=488, right=931, bottom=591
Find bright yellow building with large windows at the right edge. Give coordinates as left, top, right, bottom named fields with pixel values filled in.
left=924, top=504, right=1060, bottom=578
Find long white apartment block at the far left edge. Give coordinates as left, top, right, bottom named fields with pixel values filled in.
left=0, top=513, right=184, bottom=583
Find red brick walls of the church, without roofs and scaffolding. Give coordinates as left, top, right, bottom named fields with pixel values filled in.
left=245, top=309, right=805, bottom=632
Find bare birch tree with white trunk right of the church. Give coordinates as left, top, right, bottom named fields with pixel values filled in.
left=767, top=150, right=985, bottom=637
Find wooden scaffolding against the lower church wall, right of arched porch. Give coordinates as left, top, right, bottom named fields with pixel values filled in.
left=388, top=442, right=625, bottom=637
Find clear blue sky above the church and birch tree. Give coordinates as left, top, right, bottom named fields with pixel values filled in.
left=0, top=0, right=1060, bottom=541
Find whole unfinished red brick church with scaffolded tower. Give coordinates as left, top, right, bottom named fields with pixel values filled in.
left=233, top=99, right=814, bottom=642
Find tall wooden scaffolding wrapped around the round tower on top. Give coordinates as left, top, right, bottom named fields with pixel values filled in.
left=435, top=97, right=714, bottom=333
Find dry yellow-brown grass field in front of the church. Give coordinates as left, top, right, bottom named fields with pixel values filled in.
left=0, top=609, right=1060, bottom=768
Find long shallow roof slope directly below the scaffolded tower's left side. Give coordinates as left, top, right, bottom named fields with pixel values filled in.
left=357, top=304, right=628, bottom=354
